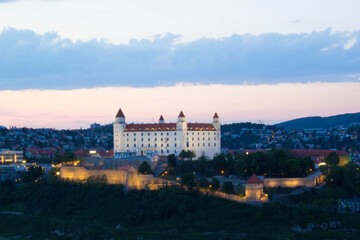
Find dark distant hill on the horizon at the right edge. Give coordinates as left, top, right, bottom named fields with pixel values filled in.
left=275, top=113, right=360, bottom=130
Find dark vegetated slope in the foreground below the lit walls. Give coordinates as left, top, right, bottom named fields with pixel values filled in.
left=0, top=177, right=360, bottom=240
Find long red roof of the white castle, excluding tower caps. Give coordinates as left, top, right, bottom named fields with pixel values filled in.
left=124, top=123, right=216, bottom=132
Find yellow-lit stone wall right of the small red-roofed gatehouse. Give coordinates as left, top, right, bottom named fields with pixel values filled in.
left=262, top=173, right=325, bottom=188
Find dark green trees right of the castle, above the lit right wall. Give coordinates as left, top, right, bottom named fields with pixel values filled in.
left=166, top=150, right=314, bottom=178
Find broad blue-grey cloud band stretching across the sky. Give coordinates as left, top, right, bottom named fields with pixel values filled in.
left=0, top=28, right=360, bottom=90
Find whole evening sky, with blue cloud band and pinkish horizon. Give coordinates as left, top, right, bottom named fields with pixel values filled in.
left=0, top=0, right=360, bottom=128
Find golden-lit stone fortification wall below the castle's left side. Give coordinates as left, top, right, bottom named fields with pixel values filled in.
left=60, top=167, right=156, bottom=190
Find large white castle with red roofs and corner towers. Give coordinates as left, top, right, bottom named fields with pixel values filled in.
left=114, top=109, right=221, bottom=157
